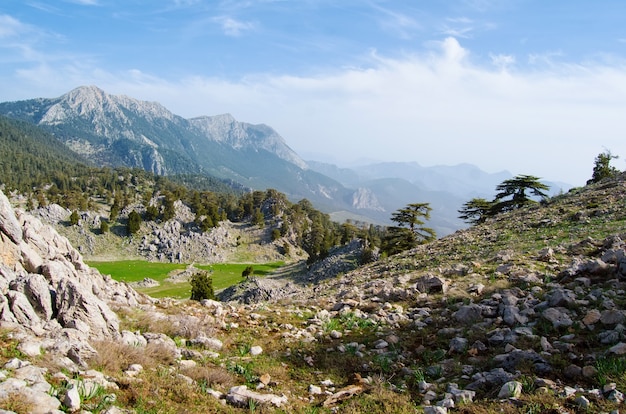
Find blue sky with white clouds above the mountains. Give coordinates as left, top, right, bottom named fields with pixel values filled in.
left=0, top=0, right=626, bottom=185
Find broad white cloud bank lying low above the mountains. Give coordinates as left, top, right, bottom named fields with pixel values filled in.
left=3, top=38, right=626, bottom=184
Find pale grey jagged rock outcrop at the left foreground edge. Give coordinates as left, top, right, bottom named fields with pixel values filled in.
left=0, top=188, right=144, bottom=360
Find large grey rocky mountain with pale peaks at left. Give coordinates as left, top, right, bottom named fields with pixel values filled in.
left=0, top=86, right=348, bottom=209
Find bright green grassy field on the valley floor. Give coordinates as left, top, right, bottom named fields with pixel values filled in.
left=87, top=260, right=284, bottom=299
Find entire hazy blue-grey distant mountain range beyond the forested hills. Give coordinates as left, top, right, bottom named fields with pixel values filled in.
left=0, top=86, right=564, bottom=235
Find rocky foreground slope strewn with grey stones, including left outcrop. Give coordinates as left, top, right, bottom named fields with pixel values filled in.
left=0, top=175, right=626, bottom=413
